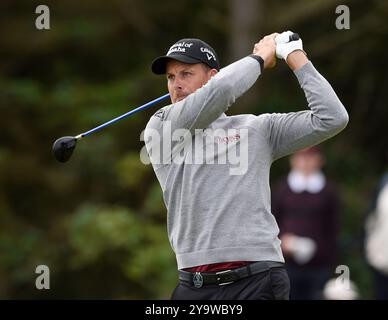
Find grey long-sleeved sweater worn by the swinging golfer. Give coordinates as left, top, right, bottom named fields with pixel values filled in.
left=144, top=57, right=348, bottom=269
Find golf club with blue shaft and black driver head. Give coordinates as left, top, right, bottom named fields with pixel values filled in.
left=52, top=93, right=170, bottom=162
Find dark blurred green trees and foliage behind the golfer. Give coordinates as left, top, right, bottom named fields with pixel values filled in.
left=0, top=0, right=388, bottom=298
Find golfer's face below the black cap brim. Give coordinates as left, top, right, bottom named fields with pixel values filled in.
left=166, top=60, right=217, bottom=103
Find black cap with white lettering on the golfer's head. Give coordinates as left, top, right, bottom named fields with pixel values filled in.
left=151, top=39, right=220, bottom=74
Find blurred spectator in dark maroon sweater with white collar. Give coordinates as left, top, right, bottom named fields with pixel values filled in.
left=272, top=146, right=339, bottom=300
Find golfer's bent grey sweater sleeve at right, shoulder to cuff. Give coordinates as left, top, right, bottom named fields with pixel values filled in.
left=266, top=53, right=349, bottom=160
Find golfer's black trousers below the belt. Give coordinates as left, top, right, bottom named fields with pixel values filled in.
left=171, top=267, right=290, bottom=300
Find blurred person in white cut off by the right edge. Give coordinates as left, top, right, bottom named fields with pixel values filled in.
left=365, top=173, right=388, bottom=300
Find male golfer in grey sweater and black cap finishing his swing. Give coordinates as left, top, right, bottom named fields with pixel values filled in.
left=144, top=31, right=348, bottom=300
